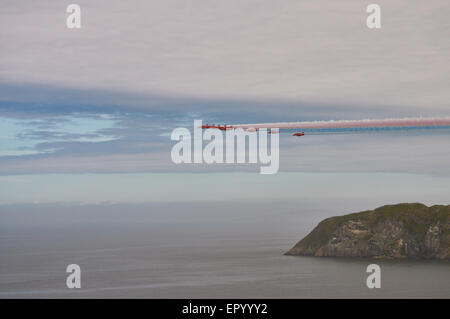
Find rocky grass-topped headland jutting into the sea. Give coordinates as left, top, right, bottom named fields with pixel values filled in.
left=286, top=203, right=450, bottom=259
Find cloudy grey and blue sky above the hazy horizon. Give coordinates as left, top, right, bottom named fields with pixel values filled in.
left=0, top=0, right=450, bottom=204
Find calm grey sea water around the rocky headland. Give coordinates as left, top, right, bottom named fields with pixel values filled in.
left=0, top=202, right=450, bottom=298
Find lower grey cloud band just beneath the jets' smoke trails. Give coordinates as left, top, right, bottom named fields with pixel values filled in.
left=0, top=130, right=450, bottom=177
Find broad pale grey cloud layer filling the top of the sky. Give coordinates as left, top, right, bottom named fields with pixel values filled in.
left=0, top=0, right=450, bottom=115
